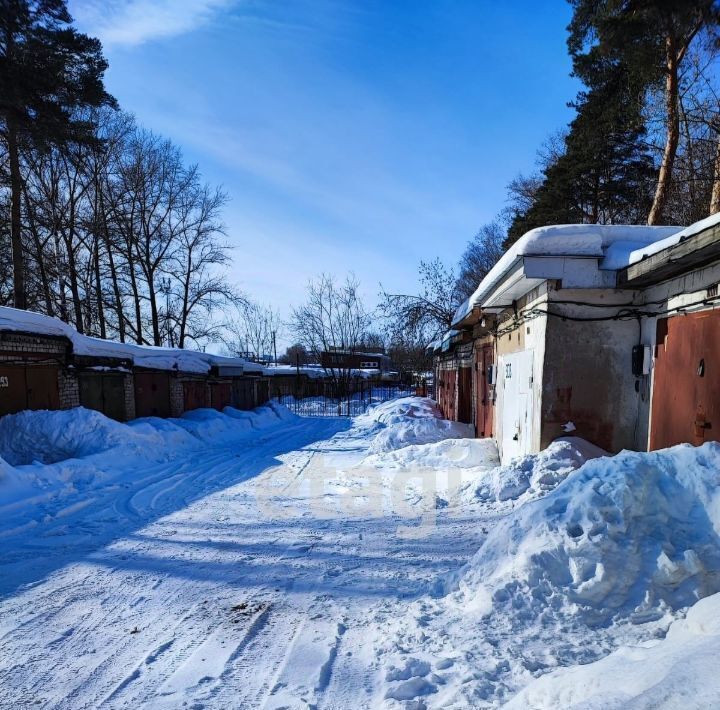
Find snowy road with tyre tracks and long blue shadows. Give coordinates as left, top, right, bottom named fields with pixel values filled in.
left=0, top=419, right=482, bottom=709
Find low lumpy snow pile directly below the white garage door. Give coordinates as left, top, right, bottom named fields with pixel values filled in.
left=459, top=437, right=607, bottom=503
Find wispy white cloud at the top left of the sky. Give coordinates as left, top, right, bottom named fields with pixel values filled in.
left=70, top=0, right=237, bottom=47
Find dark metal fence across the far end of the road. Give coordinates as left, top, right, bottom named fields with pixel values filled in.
left=270, top=382, right=416, bottom=417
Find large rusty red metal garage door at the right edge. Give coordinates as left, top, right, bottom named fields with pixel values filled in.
left=650, top=311, right=720, bottom=449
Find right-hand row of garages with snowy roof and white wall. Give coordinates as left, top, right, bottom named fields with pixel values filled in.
left=434, top=215, right=720, bottom=462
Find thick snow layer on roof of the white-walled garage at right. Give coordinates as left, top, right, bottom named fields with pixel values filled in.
left=464, top=224, right=682, bottom=312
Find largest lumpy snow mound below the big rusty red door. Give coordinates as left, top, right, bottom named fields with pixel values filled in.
left=452, top=443, right=720, bottom=626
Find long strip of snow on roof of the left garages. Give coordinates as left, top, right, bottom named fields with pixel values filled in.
left=0, top=307, right=258, bottom=382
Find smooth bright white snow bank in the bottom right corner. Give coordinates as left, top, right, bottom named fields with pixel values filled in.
left=505, top=594, right=720, bottom=710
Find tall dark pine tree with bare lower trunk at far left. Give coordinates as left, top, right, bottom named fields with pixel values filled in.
left=0, top=0, right=115, bottom=308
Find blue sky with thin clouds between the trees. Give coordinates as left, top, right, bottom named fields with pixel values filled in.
left=70, top=0, right=577, bottom=330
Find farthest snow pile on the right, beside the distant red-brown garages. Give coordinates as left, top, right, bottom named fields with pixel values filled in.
left=366, top=397, right=474, bottom=453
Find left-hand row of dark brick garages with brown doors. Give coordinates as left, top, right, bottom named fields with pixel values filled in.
left=0, top=326, right=269, bottom=421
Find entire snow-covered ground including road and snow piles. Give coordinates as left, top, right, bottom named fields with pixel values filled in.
left=0, top=398, right=720, bottom=710
